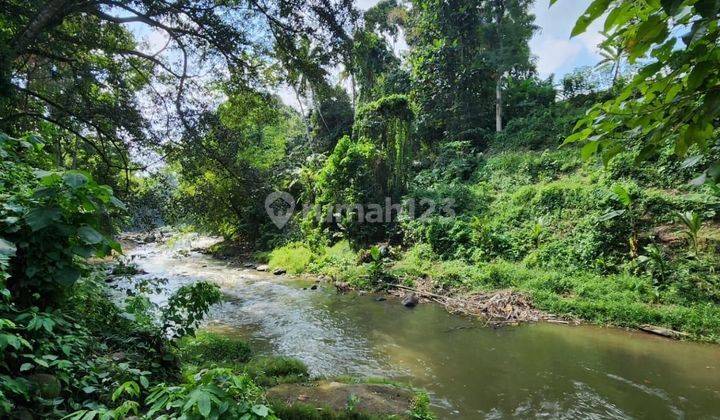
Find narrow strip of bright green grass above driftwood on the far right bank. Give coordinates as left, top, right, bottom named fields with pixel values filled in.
left=391, top=246, right=720, bottom=341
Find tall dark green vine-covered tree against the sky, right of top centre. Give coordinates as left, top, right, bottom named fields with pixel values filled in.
left=407, top=0, right=535, bottom=142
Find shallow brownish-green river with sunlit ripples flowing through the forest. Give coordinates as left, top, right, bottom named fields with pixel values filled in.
left=118, top=239, right=720, bottom=419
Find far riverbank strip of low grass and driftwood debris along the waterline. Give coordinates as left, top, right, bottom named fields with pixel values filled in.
left=211, top=242, right=720, bottom=343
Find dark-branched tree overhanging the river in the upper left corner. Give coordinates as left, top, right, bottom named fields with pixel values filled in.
left=0, top=0, right=352, bottom=189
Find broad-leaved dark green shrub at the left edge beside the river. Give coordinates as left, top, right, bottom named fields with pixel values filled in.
left=0, top=133, right=124, bottom=307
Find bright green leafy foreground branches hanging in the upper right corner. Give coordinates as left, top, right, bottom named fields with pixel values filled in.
left=564, top=0, right=720, bottom=184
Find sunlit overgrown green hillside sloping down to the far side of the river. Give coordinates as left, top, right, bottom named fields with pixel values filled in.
left=255, top=150, right=720, bottom=341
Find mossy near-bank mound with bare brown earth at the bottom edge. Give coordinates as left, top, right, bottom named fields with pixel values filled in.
left=178, top=331, right=435, bottom=420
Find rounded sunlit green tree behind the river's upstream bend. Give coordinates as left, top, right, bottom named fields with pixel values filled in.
left=168, top=89, right=303, bottom=243
